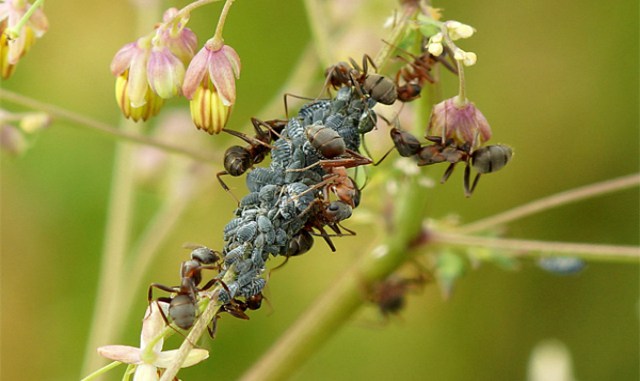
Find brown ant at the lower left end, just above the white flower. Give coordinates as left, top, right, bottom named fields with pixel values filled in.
left=147, top=247, right=226, bottom=329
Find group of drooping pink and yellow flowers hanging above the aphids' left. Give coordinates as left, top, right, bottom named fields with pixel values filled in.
left=111, top=2, right=240, bottom=134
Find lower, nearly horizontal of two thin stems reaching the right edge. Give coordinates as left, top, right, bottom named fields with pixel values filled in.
left=429, top=231, right=640, bottom=263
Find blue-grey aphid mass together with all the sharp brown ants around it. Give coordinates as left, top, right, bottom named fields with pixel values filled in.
left=148, top=56, right=511, bottom=329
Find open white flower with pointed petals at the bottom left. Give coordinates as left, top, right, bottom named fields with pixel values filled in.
left=98, top=302, right=209, bottom=381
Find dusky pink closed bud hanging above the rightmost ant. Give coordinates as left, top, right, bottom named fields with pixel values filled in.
left=426, top=96, right=491, bottom=152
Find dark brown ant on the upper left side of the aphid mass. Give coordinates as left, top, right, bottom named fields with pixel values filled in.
left=216, top=118, right=287, bottom=192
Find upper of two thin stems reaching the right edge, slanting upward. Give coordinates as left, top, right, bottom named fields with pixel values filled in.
left=454, top=173, right=640, bottom=234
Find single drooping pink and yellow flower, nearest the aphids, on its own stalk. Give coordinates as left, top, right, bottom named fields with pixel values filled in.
left=182, top=38, right=240, bottom=134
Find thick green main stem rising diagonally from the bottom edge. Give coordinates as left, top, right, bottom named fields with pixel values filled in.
left=242, top=175, right=427, bottom=381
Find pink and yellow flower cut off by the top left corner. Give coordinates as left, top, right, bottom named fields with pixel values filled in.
left=0, top=0, right=49, bottom=79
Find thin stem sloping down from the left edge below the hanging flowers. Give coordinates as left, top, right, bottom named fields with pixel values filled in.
left=0, top=89, right=220, bottom=163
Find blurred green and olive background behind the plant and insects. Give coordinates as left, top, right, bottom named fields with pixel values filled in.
left=0, top=0, right=640, bottom=381
